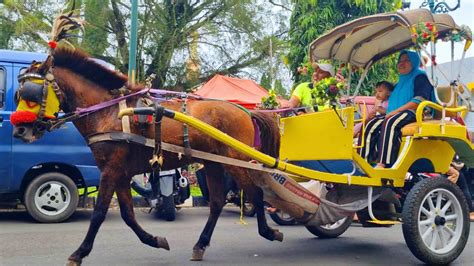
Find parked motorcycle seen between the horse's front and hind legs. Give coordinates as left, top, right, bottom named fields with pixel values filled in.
left=131, top=169, right=191, bottom=221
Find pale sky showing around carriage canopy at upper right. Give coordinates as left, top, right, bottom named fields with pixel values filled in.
left=410, top=0, right=474, bottom=64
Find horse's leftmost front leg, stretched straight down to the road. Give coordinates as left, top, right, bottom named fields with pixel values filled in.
left=68, top=174, right=115, bottom=265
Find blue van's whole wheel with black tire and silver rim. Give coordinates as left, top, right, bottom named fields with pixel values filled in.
left=23, top=172, right=79, bottom=223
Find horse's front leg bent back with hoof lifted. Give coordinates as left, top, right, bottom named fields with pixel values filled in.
left=116, top=179, right=170, bottom=250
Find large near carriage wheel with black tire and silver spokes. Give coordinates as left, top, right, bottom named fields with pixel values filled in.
left=402, top=178, right=470, bottom=264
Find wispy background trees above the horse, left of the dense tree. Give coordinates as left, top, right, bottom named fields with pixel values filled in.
left=0, top=0, right=288, bottom=89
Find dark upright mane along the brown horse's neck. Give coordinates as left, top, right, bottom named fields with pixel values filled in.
left=53, top=47, right=127, bottom=90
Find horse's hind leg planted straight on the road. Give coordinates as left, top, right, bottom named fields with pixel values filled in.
left=191, top=162, right=225, bottom=260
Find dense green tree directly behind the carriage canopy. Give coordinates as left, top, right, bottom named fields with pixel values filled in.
left=288, top=0, right=401, bottom=94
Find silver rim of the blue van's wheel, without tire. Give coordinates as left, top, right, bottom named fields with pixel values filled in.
left=34, top=181, right=71, bottom=215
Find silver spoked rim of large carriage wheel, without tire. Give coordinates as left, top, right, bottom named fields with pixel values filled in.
left=418, top=188, right=463, bottom=254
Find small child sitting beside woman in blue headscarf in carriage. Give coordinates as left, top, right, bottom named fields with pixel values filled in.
left=354, top=80, right=394, bottom=137
